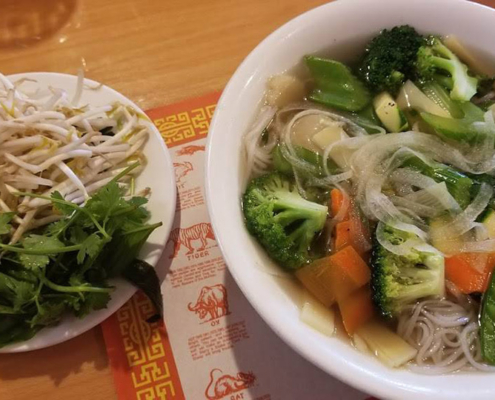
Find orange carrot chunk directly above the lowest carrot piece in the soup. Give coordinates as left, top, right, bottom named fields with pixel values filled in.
left=328, top=246, right=371, bottom=300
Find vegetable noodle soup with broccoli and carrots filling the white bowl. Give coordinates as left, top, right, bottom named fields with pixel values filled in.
left=242, top=26, right=495, bottom=374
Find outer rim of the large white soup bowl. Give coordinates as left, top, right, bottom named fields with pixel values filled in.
left=205, top=0, right=495, bottom=400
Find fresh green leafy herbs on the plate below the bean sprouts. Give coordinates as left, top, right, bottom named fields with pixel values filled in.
left=0, top=163, right=162, bottom=347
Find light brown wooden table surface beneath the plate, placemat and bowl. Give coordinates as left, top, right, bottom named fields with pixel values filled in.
left=0, top=0, right=495, bottom=400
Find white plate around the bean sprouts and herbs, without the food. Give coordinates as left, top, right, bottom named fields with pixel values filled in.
left=0, top=72, right=176, bottom=353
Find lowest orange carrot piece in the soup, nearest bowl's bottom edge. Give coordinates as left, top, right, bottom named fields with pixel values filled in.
left=339, top=286, right=374, bottom=335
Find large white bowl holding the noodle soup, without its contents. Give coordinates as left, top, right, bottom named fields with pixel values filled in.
left=206, top=0, right=495, bottom=400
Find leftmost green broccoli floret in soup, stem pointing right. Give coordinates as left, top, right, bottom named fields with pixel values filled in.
left=243, top=172, right=328, bottom=270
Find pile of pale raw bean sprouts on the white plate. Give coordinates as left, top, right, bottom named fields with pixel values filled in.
left=0, top=73, right=150, bottom=243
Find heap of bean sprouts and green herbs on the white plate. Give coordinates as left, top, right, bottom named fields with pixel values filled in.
left=0, top=74, right=162, bottom=347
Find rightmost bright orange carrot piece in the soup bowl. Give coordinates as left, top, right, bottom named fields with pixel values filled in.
left=445, top=253, right=495, bottom=294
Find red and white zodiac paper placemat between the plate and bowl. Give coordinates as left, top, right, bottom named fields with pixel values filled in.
left=102, top=93, right=372, bottom=400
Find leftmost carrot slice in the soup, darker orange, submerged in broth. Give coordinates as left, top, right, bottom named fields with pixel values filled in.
left=295, top=257, right=335, bottom=307
